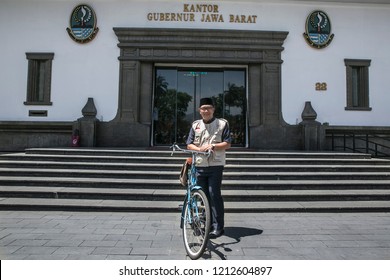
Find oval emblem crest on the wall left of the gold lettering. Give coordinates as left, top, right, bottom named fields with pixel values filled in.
left=66, top=4, right=99, bottom=44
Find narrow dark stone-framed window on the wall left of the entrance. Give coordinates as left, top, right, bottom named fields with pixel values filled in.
left=24, top=53, right=54, bottom=105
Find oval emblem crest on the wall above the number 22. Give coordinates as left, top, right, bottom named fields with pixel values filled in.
left=303, top=11, right=334, bottom=49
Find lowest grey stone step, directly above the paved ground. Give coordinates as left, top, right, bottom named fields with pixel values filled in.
left=0, top=198, right=390, bottom=212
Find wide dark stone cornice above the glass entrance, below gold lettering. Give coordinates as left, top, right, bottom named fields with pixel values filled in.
left=114, top=27, right=288, bottom=63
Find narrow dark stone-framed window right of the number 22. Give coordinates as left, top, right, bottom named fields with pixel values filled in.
left=344, top=59, right=371, bottom=111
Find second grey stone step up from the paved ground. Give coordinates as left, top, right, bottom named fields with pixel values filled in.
left=0, top=186, right=390, bottom=202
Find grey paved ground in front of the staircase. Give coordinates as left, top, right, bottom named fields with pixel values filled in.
left=0, top=211, right=390, bottom=260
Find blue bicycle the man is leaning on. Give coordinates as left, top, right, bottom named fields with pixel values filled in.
left=170, top=144, right=211, bottom=260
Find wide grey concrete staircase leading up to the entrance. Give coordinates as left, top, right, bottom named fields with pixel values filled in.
left=0, top=148, right=390, bottom=212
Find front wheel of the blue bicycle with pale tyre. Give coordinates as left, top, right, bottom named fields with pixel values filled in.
left=183, top=190, right=211, bottom=260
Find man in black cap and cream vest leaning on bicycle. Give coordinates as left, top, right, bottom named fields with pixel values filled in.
left=187, top=98, right=231, bottom=238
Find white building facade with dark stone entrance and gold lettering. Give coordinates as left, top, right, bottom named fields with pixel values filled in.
left=0, top=0, right=390, bottom=151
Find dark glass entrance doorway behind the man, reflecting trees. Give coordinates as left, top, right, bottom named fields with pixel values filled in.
left=152, top=67, right=247, bottom=147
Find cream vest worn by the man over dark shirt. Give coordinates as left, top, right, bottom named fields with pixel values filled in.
left=192, top=118, right=227, bottom=167
